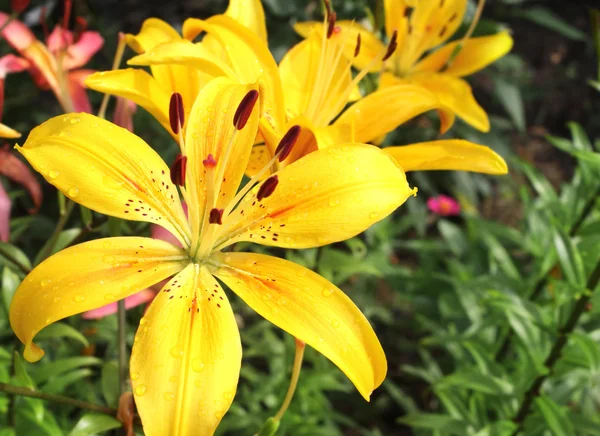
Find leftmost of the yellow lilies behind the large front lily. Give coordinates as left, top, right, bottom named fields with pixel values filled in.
left=85, top=0, right=281, bottom=138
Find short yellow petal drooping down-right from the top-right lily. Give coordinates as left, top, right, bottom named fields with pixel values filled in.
left=410, top=73, right=490, bottom=132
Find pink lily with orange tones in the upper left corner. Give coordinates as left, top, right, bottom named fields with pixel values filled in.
left=0, top=12, right=104, bottom=112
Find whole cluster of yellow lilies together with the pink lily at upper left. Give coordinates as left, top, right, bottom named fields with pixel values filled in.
left=5, top=0, right=510, bottom=435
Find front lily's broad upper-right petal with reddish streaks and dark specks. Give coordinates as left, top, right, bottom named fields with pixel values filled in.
left=219, top=144, right=414, bottom=248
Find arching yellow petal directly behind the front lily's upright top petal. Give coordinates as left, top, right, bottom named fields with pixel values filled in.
left=183, top=15, right=285, bottom=133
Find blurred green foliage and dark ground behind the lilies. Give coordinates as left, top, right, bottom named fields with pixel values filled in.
left=0, top=0, right=600, bottom=436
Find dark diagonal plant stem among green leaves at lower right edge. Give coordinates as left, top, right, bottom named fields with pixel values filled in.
left=513, top=261, right=600, bottom=430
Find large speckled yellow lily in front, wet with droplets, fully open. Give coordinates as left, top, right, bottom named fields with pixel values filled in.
left=10, top=78, right=415, bottom=435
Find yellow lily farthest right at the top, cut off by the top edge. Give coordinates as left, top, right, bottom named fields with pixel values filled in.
left=294, top=0, right=513, bottom=132
